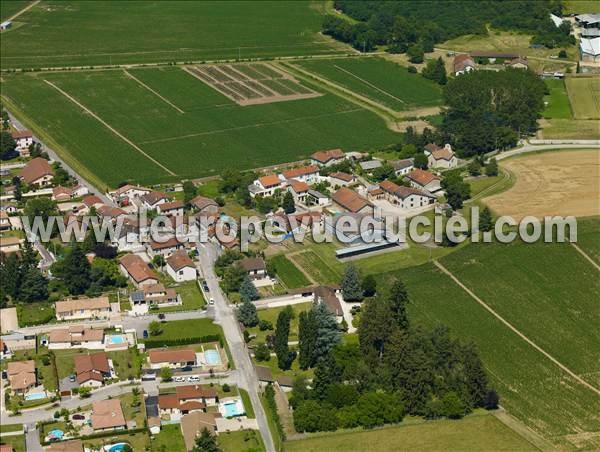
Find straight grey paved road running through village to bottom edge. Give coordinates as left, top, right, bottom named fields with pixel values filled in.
left=199, top=243, right=275, bottom=452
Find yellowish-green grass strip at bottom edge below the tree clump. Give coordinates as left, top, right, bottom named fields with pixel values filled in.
left=283, top=414, right=538, bottom=452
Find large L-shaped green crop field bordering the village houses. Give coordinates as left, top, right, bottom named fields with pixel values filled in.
left=2, top=67, right=400, bottom=187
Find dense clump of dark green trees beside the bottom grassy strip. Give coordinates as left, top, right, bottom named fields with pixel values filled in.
left=290, top=280, right=498, bottom=432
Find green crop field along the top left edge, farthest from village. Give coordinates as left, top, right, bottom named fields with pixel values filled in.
left=0, top=0, right=344, bottom=69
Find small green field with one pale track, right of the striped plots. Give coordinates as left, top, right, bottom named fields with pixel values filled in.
left=293, top=57, right=442, bottom=111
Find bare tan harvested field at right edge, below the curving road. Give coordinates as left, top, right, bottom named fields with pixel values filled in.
left=486, top=150, right=600, bottom=221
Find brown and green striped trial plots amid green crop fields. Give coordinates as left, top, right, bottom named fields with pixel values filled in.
left=186, top=63, right=321, bottom=106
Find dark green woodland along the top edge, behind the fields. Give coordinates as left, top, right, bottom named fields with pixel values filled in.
left=323, top=0, right=574, bottom=54
